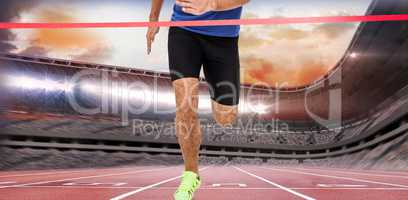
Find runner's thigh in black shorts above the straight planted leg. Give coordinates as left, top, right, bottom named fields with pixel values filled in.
left=168, top=27, right=203, bottom=81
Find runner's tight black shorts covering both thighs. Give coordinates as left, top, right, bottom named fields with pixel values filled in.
left=168, top=27, right=240, bottom=105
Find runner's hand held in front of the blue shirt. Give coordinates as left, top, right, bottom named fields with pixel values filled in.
left=176, top=0, right=217, bottom=15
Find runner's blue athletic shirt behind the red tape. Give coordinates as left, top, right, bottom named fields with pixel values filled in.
left=171, top=5, right=242, bottom=37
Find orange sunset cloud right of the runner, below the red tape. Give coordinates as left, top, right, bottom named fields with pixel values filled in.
left=240, top=15, right=357, bottom=87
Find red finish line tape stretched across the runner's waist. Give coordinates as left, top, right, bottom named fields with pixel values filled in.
left=0, top=14, right=408, bottom=29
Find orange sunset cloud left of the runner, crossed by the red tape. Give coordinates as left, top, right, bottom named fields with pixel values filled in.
left=21, top=9, right=111, bottom=61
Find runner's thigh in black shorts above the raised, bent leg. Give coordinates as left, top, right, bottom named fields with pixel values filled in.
left=202, top=37, right=240, bottom=106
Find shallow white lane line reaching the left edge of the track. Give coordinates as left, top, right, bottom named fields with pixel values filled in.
left=0, top=167, right=172, bottom=189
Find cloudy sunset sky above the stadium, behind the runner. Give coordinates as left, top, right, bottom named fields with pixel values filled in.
left=0, top=0, right=371, bottom=87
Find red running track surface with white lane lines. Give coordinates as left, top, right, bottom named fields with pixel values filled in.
left=0, top=166, right=408, bottom=200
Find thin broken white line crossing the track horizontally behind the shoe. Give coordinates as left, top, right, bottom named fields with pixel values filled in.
left=15, top=185, right=408, bottom=191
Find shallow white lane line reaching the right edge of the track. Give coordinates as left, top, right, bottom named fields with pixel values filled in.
left=262, top=167, right=408, bottom=188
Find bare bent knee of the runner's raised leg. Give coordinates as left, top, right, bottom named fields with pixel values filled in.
left=213, top=102, right=238, bottom=127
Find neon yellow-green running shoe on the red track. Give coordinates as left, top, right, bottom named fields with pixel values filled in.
left=174, top=171, right=201, bottom=200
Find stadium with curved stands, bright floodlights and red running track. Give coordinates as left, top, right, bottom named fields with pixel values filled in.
left=0, top=0, right=408, bottom=200
